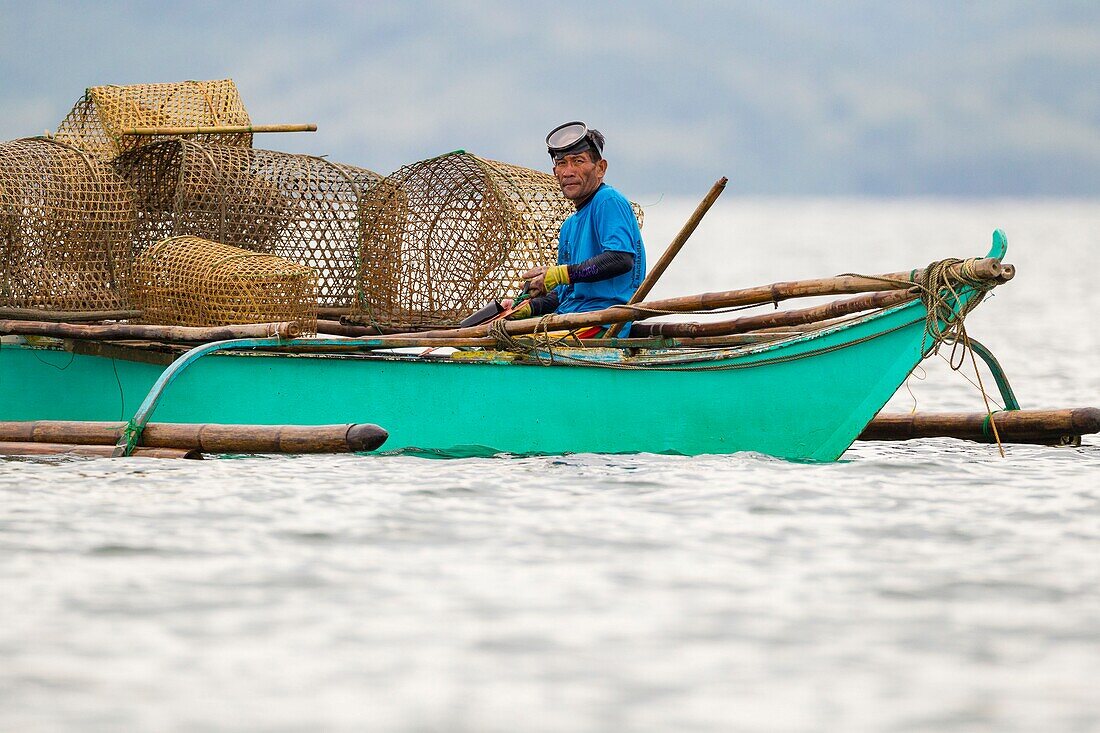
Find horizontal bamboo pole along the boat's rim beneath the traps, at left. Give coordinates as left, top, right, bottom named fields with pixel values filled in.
left=0, top=320, right=301, bottom=341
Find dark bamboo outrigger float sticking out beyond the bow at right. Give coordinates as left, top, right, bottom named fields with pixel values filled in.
left=859, top=407, right=1100, bottom=445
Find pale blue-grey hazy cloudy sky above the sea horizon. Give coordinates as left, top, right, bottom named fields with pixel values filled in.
left=0, top=0, right=1100, bottom=200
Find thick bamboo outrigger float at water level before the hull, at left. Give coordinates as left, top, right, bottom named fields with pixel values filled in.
left=0, top=420, right=388, bottom=456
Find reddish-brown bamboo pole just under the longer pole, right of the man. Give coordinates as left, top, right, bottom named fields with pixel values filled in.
left=631, top=291, right=916, bottom=338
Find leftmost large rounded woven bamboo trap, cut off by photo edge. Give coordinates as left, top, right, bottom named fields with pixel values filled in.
left=0, top=138, right=134, bottom=311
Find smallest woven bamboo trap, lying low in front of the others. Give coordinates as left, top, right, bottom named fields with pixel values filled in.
left=132, top=236, right=317, bottom=333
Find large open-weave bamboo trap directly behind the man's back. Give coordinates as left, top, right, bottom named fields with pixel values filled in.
left=359, top=151, right=640, bottom=326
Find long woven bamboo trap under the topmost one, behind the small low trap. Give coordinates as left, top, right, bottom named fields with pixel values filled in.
left=114, top=139, right=382, bottom=308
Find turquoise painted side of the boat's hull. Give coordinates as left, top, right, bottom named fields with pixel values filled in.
left=0, top=236, right=1004, bottom=461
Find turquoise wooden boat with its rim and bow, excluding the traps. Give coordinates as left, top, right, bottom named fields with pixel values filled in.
left=0, top=231, right=1013, bottom=461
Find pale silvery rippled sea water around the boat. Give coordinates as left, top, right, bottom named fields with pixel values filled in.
left=0, top=197, right=1100, bottom=732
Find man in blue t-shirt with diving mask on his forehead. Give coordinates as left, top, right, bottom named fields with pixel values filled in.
left=502, top=122, right=646, bottom=337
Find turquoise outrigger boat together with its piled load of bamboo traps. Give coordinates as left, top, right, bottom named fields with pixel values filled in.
left=0, top=79, right=1029, bottom=461
